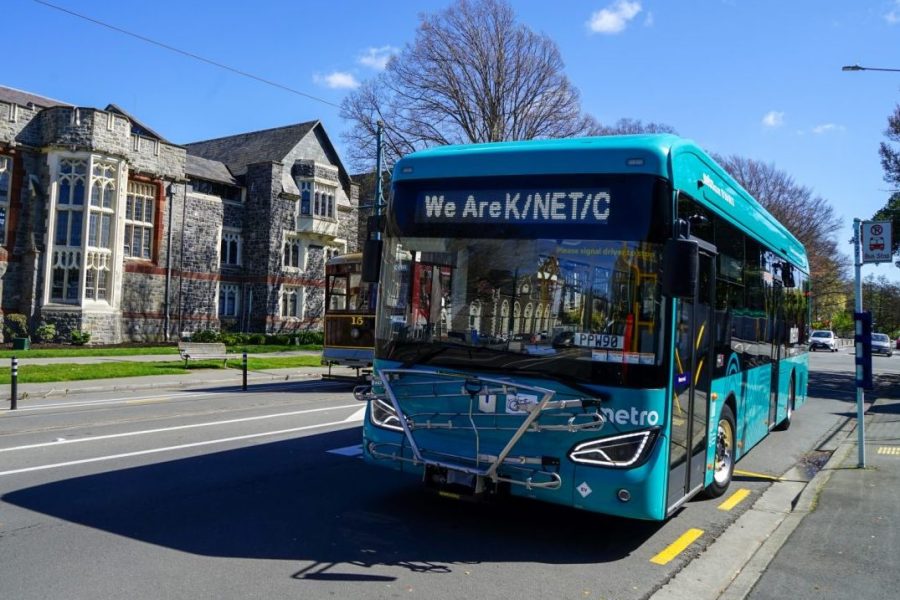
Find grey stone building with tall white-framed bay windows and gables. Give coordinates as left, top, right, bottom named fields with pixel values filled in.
left=0, top=87, right=358, bottom=343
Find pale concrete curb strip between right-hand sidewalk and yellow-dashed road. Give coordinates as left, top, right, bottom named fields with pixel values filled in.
left=651, top=419, right=855, bottom=600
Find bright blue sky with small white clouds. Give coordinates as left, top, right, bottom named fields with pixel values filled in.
left=7, top=0, right=900, bottom=281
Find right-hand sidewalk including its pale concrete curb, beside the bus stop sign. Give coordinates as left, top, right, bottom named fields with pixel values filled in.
left=652, top=372, right=900, bottom=600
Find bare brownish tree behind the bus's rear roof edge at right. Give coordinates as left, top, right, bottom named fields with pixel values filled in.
left=714, top=156, right=849, bottom=318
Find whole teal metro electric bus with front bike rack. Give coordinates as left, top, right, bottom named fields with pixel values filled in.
left=357, top=135, right=809, bottom=520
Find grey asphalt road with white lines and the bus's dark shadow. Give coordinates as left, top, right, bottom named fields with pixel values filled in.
left=0, top=351, right=900, bottom=600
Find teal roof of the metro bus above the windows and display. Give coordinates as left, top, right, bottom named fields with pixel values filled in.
left=393, top=134, right=809, bottom=271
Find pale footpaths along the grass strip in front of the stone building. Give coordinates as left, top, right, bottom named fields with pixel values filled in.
left=0, top=350, right=356, bottom=411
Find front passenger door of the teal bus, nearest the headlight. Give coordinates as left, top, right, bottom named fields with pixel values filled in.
left=666, top=240, right=716, bottom=512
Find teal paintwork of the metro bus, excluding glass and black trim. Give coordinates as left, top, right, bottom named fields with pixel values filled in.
left=363, top=134, right=809, bottom=520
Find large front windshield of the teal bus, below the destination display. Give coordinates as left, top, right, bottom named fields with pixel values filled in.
left=376, top=236, right=665, bottom=387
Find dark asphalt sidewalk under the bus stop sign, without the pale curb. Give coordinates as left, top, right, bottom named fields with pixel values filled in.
left=740, top=384, right=900, bottom=600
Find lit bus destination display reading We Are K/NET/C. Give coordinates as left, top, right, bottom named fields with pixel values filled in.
left=416, top=189, right=610, bottom=225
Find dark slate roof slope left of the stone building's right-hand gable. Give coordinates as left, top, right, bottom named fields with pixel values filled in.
left=184, top=121, right=319, bottom=175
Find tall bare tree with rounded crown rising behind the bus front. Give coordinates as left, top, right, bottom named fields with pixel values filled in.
left=341, top=0, right=598, bottom=170
